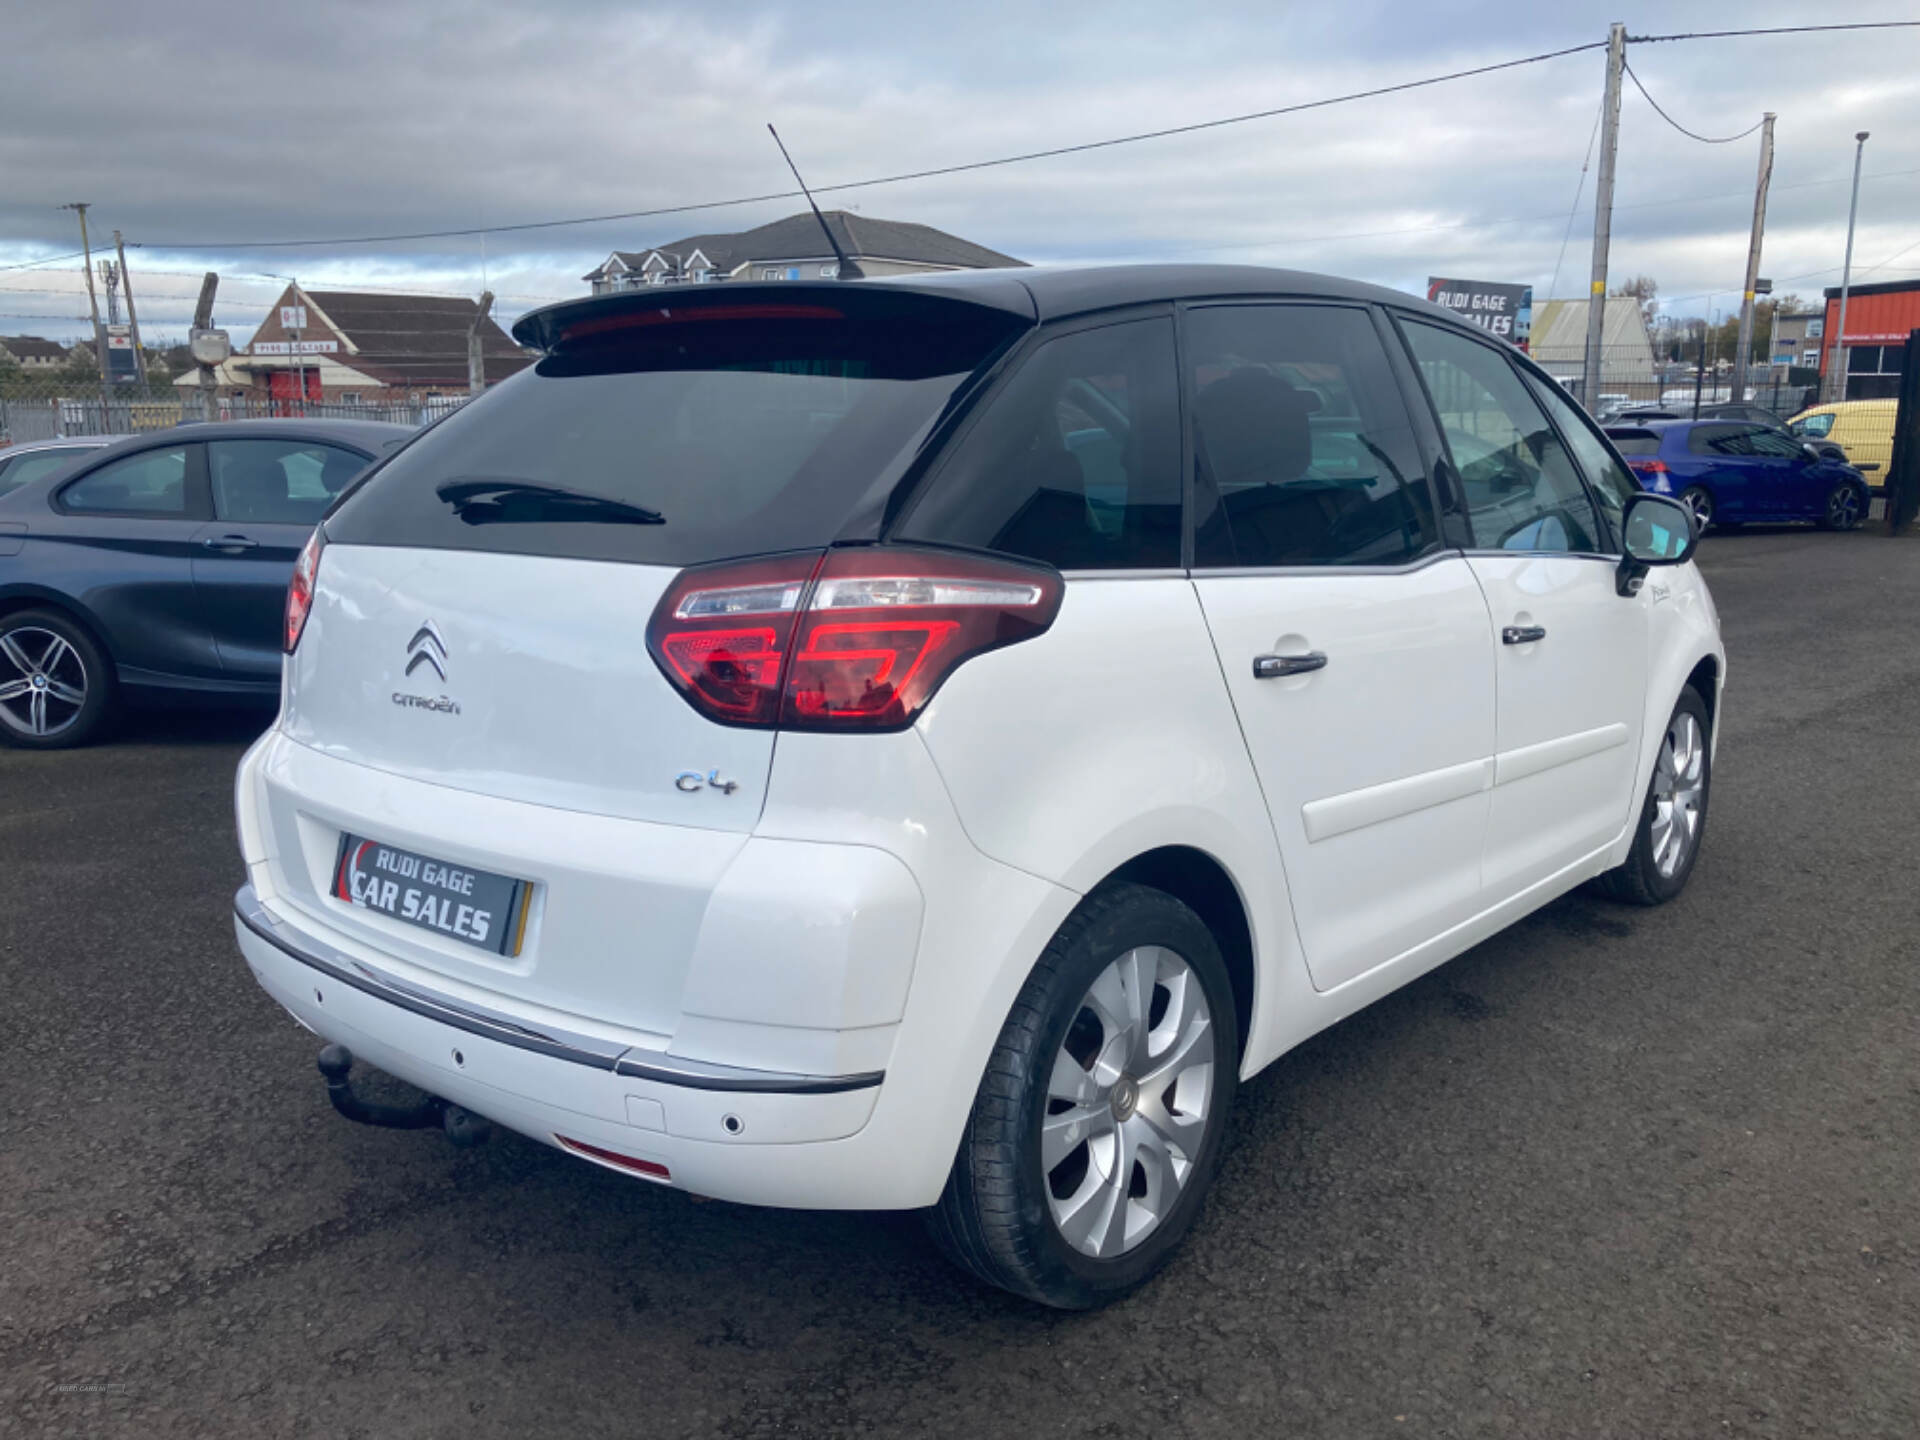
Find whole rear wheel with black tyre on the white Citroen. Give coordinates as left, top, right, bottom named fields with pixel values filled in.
left=927, top=885, right=1240, bottom=1309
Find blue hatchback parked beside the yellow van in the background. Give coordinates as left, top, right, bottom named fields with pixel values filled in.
left=1607, top=420, right=1870, bottom=530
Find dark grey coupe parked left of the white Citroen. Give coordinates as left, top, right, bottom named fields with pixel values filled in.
left=0, top=420, right=415, bottom=747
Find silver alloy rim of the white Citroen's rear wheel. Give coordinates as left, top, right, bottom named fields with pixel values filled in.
left=1039, top=945, right=1213, bottom=1260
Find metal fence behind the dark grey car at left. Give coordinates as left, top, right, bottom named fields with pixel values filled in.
left=0, top=376, right=468, bottom=445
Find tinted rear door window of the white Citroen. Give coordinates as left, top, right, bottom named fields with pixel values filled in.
left=1187, top=305, right=1434, bottom=566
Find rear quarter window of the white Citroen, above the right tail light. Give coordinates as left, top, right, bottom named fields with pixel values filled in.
left=900, top=317, right=1181, bottom=570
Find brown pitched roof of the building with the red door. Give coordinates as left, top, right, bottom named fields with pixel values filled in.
left=289, top=286, right=528, bottom=386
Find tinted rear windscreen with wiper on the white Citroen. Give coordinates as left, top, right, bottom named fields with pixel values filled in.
left=326, top=298, right=1029, bottom=564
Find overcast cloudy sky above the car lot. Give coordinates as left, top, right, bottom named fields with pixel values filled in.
left=0, top=0, right=1920, bottom=340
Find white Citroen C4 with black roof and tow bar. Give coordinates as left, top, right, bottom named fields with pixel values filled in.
left=234, top=267, right=1724, bottom=1306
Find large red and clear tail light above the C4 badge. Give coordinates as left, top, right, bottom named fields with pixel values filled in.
left=647, top=547, right=1064, bottom=730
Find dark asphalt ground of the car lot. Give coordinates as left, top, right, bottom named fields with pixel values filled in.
left=0, top=530, right=1920, bottom=1440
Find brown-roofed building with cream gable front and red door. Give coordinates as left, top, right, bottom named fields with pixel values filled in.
left=216, top=286, right=534, bottom=405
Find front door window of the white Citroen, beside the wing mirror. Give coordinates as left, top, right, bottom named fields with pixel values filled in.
left=1405, top=323, right=1599, bottom=551
